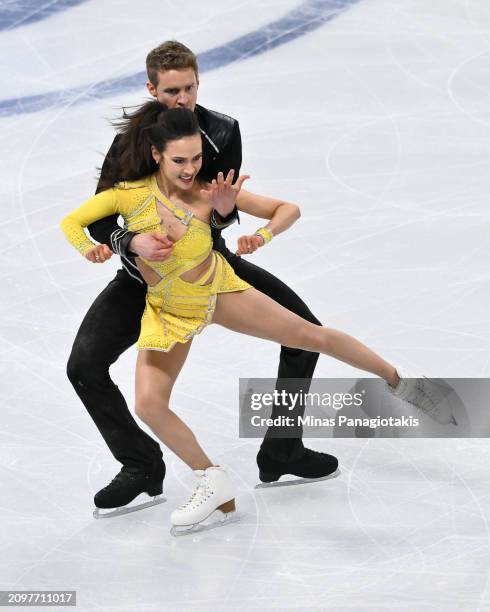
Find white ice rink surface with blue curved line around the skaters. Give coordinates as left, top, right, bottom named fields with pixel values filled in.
left=0, top=0, right=490, bottom=612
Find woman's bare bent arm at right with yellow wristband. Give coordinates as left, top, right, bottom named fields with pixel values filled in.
left=236, top=189, right=301, bottom=255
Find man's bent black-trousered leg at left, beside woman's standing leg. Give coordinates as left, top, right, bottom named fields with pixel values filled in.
left=67, top=270, right=162, bottom=473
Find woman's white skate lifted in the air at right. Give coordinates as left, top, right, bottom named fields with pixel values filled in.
left=387, top=368, right=458, bottom=425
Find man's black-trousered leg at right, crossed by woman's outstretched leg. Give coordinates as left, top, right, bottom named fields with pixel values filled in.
left=222, top=252, right=337, bottom=475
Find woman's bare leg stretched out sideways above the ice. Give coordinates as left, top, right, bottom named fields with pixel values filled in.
left=213, top=288, right=399, bottom=386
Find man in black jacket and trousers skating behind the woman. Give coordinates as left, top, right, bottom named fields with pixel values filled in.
left=67, top=41, right=338, bottom=509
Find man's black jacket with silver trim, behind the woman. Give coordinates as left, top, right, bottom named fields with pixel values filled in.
left=88, top=104, right=242, bottom=280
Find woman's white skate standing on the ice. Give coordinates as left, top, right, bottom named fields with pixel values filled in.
left=170, top=466, right=239, bottom=536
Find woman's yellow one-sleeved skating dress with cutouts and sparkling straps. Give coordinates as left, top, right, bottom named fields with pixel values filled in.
left=61, top=175, right=251, bottom=352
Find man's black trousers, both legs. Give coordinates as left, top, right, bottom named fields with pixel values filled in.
left=67, top=250, right=321, bottom=471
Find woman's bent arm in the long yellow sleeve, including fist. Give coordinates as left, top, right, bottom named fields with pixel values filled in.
left=61, top=188, right=120, bottom=261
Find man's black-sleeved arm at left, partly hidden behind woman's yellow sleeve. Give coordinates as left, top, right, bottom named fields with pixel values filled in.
left=87, top=135, right=136, bottom=257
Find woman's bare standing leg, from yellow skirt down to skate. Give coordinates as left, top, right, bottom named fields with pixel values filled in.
left=136, top=342, right=213, bottom=470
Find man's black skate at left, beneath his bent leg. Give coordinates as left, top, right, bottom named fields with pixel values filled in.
left=94, top=461, right=166, bottom=518
